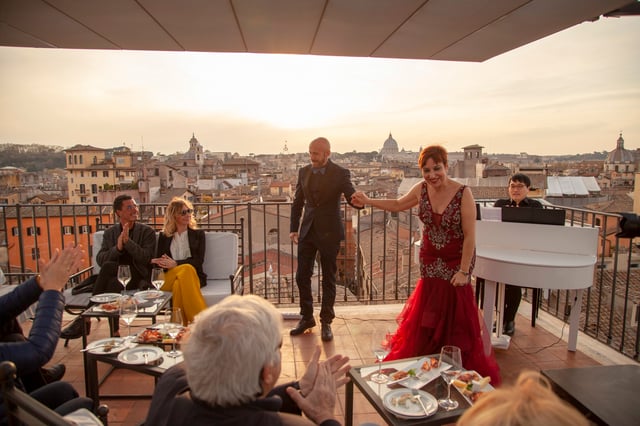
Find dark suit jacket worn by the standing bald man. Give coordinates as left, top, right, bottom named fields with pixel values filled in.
left=290, top=160, right=359, bottom=242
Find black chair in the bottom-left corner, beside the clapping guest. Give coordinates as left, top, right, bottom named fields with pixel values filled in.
left=0, top=361, right=109, bottom=426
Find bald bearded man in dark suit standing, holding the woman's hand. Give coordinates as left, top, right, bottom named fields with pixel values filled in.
left=289, top=138, right=362, bottom=342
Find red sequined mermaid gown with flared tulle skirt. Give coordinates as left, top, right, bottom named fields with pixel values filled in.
left=385, top=182, right=501, bottom=386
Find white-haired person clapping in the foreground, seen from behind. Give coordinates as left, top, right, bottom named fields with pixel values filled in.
left=145, top=295, right=350, bottom=426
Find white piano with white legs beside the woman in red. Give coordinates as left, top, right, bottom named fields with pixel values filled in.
left=473, top=220, right=599, bottom=351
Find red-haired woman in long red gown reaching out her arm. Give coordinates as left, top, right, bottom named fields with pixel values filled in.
left=352, top=145, right=501, bottom=385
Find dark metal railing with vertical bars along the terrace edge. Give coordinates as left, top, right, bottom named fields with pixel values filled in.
left=0, top=200, right=640, bottom=360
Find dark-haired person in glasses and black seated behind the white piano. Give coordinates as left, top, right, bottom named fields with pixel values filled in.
left=493, top=173, right=542, bottom=336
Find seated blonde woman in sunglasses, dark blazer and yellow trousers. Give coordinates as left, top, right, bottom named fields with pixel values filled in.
left=151, top=197, right=207, bottom=325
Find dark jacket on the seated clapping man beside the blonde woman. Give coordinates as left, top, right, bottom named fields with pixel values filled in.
left=96, top=222, right=156, bottom=288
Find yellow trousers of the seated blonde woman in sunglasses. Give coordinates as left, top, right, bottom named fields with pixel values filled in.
left=161, top=264, right=207, bottom=325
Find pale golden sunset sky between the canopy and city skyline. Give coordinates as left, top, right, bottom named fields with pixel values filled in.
left=0, top=17, right=640, bottom=155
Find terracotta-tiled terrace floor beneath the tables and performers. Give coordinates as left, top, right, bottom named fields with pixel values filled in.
left=25, top=300, right=634, bottom=426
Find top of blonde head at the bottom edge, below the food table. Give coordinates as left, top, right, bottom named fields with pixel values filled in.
left=456, top=371, right=590, bottom=426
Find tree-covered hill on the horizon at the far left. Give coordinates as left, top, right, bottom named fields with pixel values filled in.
left=0, top=143, right=66, bottom=172
